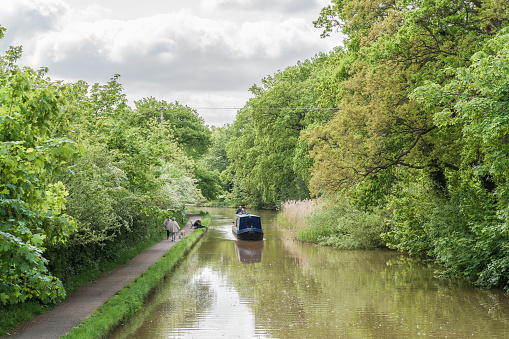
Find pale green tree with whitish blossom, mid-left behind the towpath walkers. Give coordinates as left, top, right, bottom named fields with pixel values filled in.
left=56, top=75, right=197, bottom=244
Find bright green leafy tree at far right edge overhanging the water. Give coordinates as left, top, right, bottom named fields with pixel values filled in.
left=402, top=29, right=509, bottom=289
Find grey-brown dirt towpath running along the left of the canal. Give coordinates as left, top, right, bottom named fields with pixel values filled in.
left=2, top=214, right=200, bottom=339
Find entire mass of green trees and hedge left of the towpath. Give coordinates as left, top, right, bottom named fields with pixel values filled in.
left=0, top=21, right=208, bottom=314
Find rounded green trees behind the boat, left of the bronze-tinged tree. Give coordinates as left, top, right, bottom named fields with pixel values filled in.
left=223, top=52, right=339, bottom=207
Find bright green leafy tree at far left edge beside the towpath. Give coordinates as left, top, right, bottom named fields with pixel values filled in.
left=0, top=42, right=76, bottom=304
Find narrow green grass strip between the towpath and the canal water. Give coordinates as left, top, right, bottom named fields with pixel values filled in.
left=62, top=227, right=206, bottom=338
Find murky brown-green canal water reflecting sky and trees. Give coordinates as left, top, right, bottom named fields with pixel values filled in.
left=110, top=208, right=509, bottom=339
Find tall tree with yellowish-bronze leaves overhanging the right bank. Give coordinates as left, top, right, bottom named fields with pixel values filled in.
left=308, top=0, right=503, bottom=197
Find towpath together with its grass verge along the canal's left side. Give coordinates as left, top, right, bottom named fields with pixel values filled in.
left=3, top=214, right=205, bottom=339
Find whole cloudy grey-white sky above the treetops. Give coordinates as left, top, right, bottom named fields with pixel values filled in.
left=0, top=0, right=341, bottom=126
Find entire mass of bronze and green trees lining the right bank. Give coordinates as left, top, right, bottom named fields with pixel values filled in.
left=274, top=0, right=509, bottom=289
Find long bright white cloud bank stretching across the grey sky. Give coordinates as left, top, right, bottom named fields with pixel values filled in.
left=20, top=12, right=322, bottom=65
